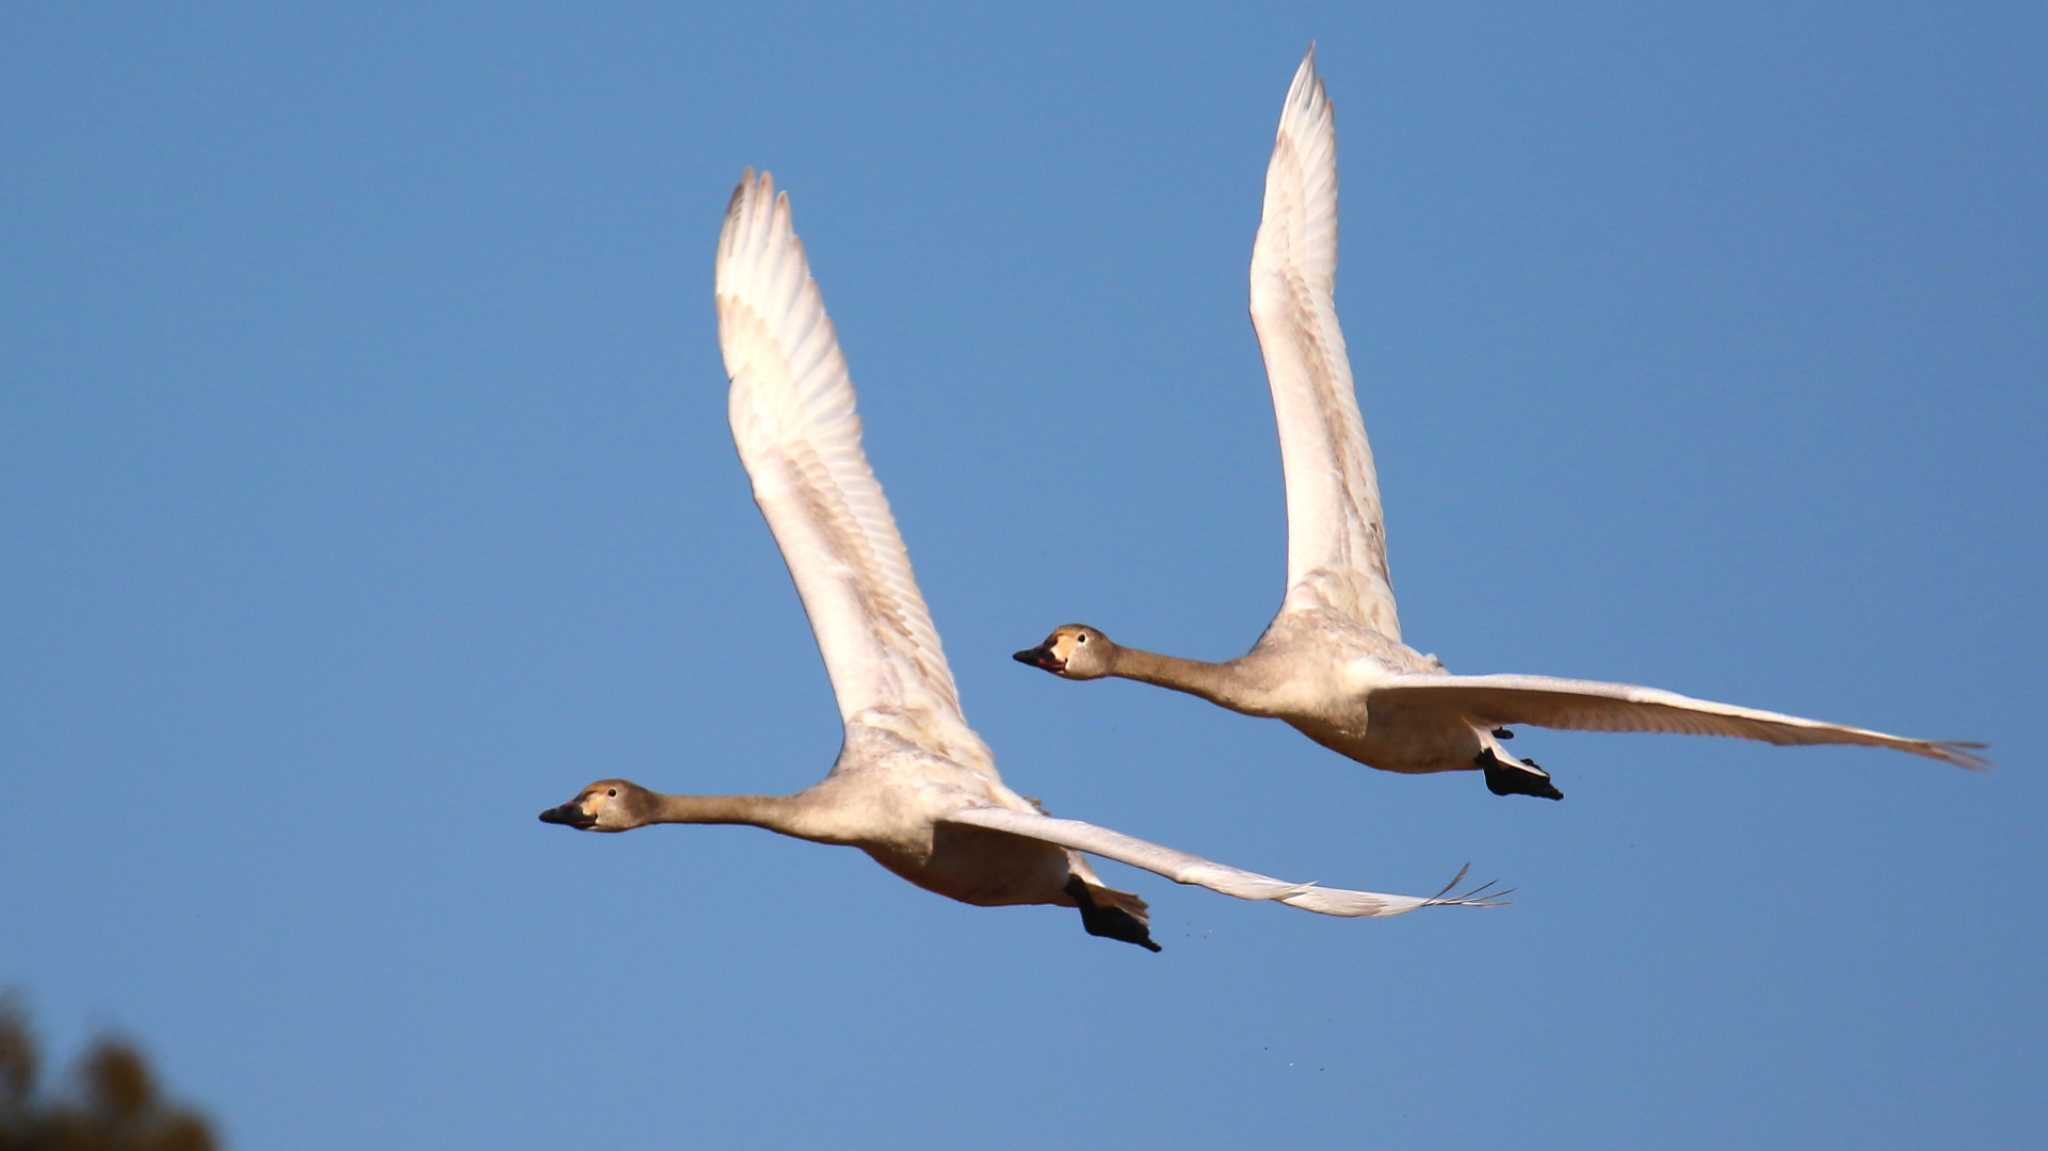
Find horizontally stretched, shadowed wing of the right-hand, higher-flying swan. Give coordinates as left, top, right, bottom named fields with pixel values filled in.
left=1366, top=676, right=1991, bottom=768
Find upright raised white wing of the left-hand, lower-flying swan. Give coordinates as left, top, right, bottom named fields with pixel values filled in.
left=717, top=170, right=987, bottom=760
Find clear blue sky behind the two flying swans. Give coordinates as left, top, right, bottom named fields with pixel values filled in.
left=0, top=4, right=2048, bottom=1149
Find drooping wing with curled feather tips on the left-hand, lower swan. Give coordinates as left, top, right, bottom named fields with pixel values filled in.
left=940, top=807, right=1501, bottom=918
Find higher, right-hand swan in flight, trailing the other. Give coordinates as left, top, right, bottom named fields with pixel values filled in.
left=1016, top=45, right=1987, bottom=799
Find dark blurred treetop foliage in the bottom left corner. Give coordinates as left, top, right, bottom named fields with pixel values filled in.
left=0, top=999, right=217, bottom=1151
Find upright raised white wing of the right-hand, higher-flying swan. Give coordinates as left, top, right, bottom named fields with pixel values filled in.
left=1251, top=47, right=1401, bottom=639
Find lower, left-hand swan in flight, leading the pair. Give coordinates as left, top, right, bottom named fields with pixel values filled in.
left=541, top=172, right=1497, bottom=950
